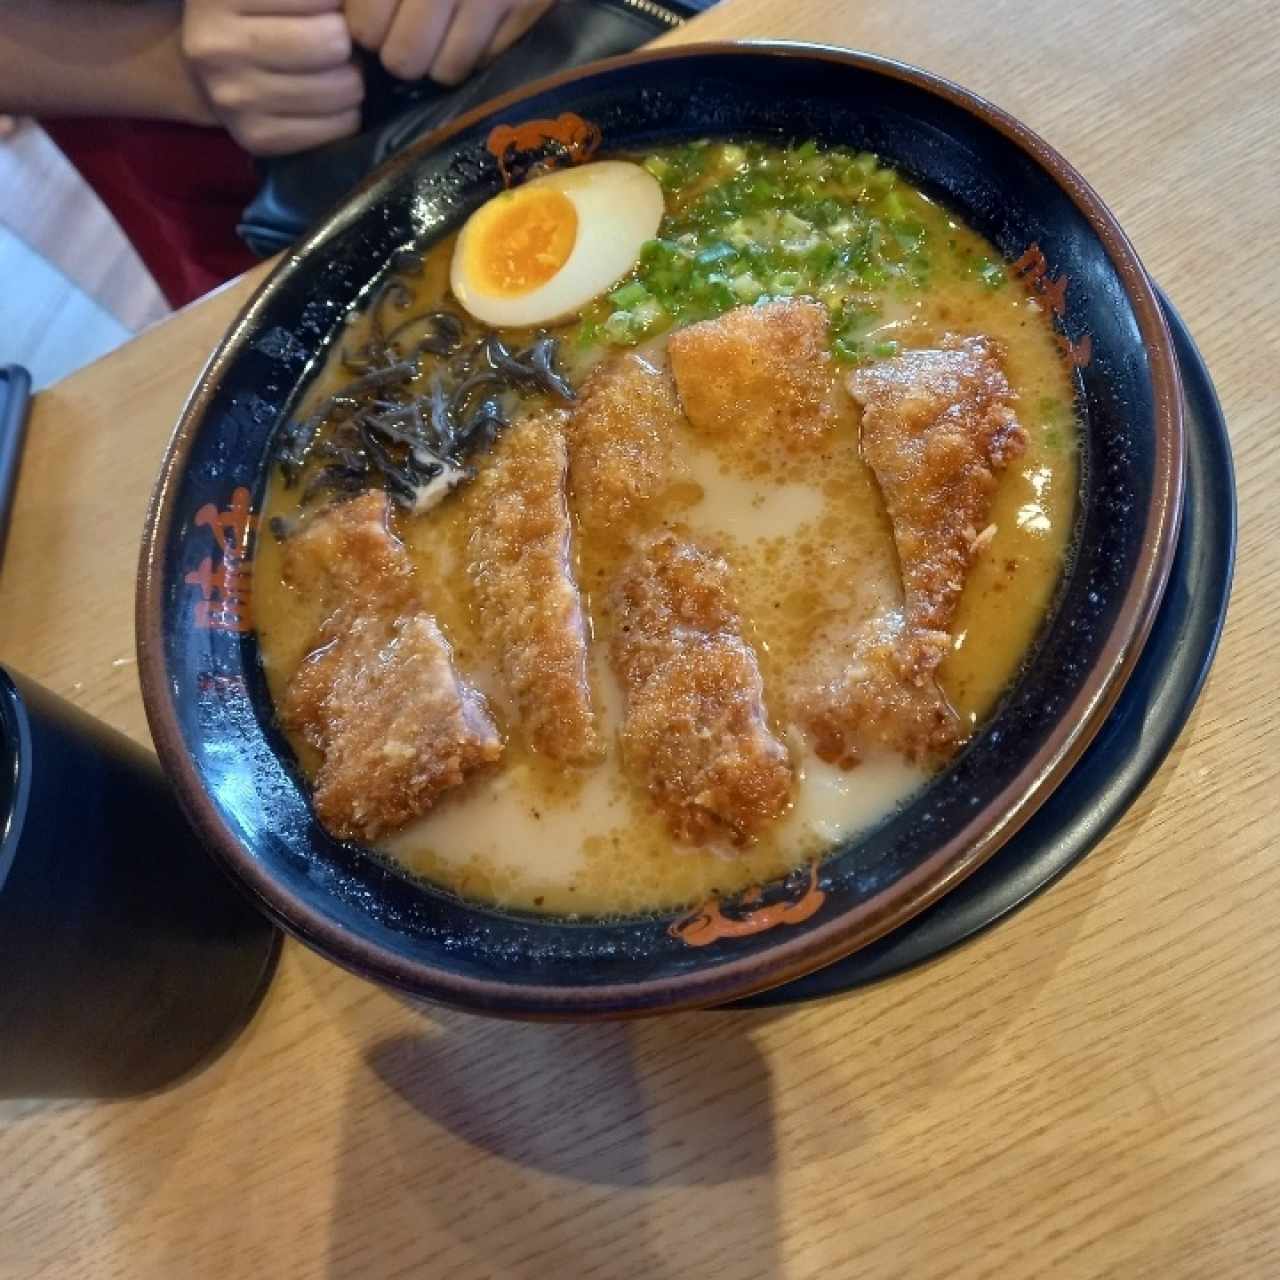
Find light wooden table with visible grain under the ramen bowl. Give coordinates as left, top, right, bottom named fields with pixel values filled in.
left=0, top=0, right=1280, bottom=1280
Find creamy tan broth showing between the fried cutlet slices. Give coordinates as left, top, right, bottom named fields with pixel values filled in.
left=255, top=145, right=1078, bottom=915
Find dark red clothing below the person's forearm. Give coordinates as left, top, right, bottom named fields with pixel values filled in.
left=41, top=119, right=259, bottom=307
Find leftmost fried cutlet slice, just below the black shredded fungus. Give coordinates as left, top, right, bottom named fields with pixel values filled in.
left=280, top=493, right=502, bottom=841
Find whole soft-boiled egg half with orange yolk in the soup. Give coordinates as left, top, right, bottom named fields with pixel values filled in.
left=449, top=160, right=663, bottom=329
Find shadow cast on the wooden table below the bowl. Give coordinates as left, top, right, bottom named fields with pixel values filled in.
left=322, top=1011, right=778, bottom=1280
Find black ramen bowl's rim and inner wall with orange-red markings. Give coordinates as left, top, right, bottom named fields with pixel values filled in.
left=138, top=45, right=1183, bottom=1016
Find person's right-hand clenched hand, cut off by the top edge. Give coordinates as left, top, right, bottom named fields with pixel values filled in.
left=346, top=0, right=554, bottom=84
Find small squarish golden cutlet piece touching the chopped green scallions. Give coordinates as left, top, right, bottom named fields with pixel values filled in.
left=667, top=298, right=837, bottom=448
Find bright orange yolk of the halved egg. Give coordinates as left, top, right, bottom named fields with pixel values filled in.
left=467, top=187, right=577, bottom=298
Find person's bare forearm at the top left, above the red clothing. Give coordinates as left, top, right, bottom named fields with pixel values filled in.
left=0, top=0, right=214, bottom=124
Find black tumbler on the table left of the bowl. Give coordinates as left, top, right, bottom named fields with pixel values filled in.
left=0, top=669, right=279, bottom=1098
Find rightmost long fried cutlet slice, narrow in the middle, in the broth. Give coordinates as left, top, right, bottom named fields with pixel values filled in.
left=794, top=337, right=1027, bottom=768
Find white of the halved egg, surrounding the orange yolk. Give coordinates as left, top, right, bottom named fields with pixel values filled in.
left=449, top=160, right=664, bottom=329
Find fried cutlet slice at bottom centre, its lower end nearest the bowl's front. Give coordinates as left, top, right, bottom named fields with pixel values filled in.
left=612, top=532, right=792, bottom=845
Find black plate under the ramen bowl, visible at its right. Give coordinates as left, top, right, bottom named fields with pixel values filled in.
left=737, top=294, right=1235, bottom=1009
